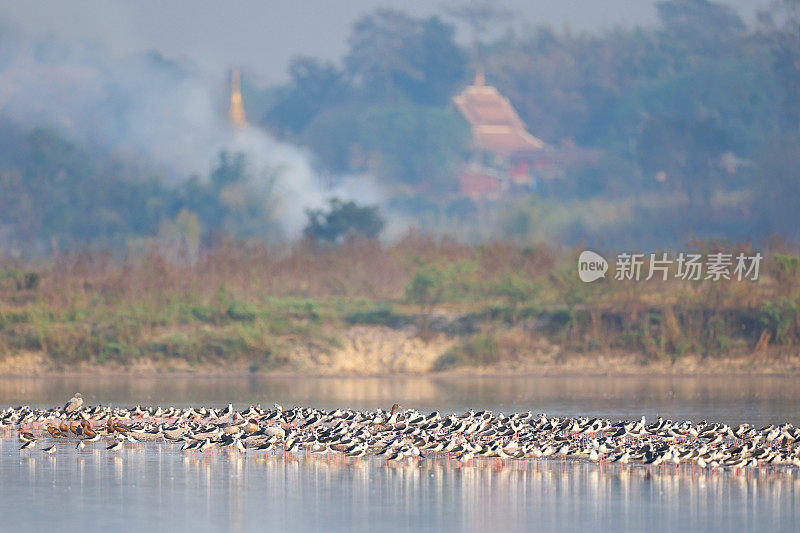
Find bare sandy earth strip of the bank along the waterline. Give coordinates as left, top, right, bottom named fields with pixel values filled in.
left=0, top=325, right=800, bottom=377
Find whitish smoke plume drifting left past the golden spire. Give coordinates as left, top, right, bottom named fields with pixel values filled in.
left=0, top=24, right=383, bottom=238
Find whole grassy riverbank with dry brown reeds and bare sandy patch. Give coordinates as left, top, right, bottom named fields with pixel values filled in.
left=0, top=241, right=800, bottom=375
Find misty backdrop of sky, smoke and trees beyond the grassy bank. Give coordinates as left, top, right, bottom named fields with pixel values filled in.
left=0, top=0, right=800, bottom=255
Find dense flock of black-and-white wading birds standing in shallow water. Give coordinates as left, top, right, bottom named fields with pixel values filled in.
left=0, top=394, right=800, bottom=471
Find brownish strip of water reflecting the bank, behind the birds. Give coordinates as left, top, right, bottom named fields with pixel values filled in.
left=0, top=374, right=800, bottom=427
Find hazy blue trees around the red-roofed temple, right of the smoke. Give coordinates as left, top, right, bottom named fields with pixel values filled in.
left=262, top=0, right=800, bottom=241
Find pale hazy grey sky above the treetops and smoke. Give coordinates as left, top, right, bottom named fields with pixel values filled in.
left=0, top=0, right=769, bottom=83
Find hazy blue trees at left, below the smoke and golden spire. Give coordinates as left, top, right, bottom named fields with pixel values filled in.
left=0, top=124, right=278, bottom=252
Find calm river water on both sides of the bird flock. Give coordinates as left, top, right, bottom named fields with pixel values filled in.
left=0, top=377, right=800, bottom=531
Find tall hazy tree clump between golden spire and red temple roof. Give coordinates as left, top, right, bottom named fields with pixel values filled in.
left=264, top=9, right=469, bottom=190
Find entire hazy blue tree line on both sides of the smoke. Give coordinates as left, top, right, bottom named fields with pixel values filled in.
left=0, top=0, right=800, bottom=252
